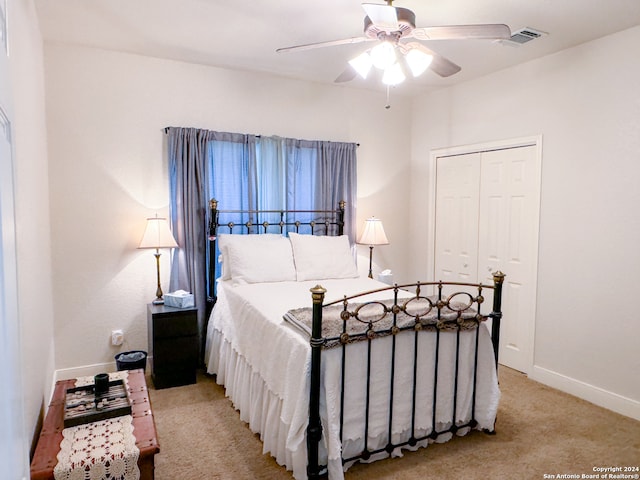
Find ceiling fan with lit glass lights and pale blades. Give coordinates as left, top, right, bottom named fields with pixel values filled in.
left=276, top=0, right=511, bottom=86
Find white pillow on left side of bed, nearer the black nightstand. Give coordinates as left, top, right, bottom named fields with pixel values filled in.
left=218, top=233, right=296, bottom=283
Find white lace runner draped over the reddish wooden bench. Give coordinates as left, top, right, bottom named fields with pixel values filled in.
left=53, top=371, right=140, bottom=480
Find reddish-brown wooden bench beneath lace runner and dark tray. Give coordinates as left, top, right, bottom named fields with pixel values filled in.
left=31, top=369, right=160, bottom=480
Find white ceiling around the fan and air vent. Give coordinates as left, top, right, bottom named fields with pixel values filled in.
left=35, top=0, right=640, bottom=94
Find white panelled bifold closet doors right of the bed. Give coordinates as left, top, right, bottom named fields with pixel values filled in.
left=434, top=146, right=539, bottom=373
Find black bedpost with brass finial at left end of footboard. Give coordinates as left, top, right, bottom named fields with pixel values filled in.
left=307, top=285, right=327, bottom=480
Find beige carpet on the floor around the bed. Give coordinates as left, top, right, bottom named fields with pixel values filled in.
left=149, top=367, right=640, bottom=480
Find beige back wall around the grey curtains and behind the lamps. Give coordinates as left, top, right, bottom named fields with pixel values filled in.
left=45, top=45, right=410, bottom=377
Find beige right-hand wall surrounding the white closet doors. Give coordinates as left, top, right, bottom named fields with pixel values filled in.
left=410, top=27, right=640, bottom=418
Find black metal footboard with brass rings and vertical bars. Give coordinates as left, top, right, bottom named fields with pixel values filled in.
left=307, top=271, right=505, bottom=479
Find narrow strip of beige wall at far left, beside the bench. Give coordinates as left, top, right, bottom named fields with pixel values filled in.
left=8, top=0, right=54, bottom=468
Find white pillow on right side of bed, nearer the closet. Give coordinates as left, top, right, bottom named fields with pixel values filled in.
left=289, top=233, right=358, bottom=282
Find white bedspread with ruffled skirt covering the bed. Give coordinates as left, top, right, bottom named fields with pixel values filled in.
left=205, top=277, right=500, bottom=479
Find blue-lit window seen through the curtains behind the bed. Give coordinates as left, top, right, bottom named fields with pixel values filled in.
left=205, top=135, right=355, bottom=288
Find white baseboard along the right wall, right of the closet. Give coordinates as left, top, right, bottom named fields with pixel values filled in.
left=529, top=365, right=640, bottom=420
